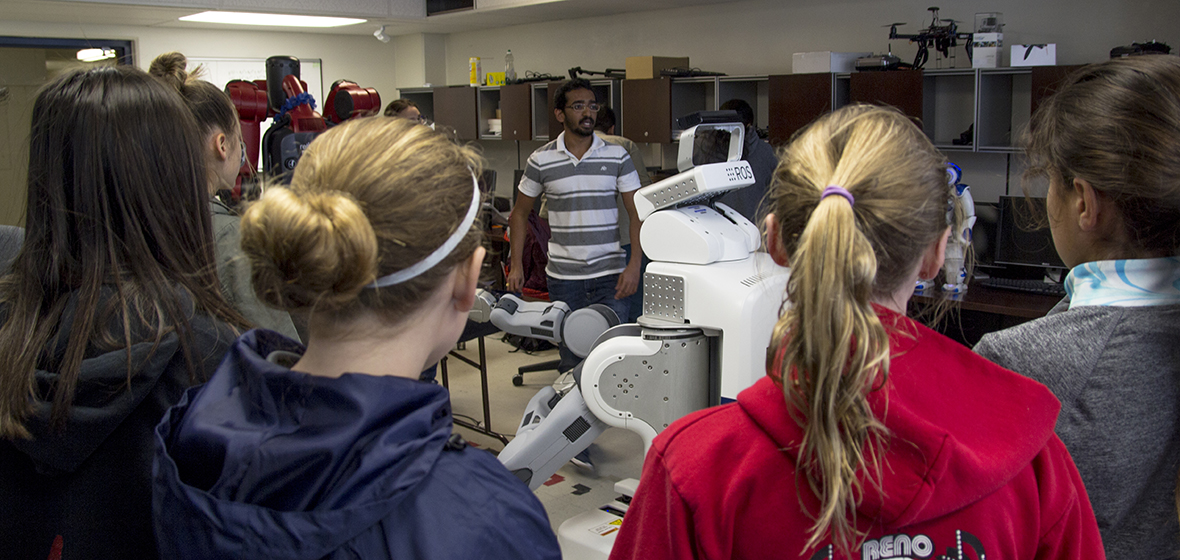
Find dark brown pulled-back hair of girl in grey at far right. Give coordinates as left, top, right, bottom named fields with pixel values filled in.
left=1024, top=55, right=1180, bottom=255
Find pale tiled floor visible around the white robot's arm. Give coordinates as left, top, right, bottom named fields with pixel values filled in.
left=439, top=332, right=643, bottom=532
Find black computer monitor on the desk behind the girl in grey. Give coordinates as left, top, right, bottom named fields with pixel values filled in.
left=995, top=197, right=1066, bottom=269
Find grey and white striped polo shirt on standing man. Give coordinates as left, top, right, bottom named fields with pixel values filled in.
left=520, top=132, right=640, bottom=279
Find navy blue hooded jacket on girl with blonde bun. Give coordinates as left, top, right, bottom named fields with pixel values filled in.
left=152, top=330, right=561, bottom=559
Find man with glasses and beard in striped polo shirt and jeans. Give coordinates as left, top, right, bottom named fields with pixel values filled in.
left=507, top=78, right=643, bottom=371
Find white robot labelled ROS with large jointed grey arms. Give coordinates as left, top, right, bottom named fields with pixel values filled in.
left=490, top=112, right=788, bottom=489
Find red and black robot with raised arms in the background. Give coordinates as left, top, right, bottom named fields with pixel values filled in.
left=225, top=57, right=381, bottom=196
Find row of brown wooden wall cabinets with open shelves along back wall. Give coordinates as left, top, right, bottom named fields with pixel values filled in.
left=410, top=66, right=1080, bottom=153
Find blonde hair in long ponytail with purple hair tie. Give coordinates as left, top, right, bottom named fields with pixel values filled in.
left=767, top=106, right=949, bottom=552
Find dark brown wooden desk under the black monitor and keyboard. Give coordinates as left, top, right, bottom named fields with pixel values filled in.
left=910, top=283, right=1061, bottom=347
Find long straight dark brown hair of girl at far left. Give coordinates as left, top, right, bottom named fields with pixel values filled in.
left=0, top=66, right=242, bottom=439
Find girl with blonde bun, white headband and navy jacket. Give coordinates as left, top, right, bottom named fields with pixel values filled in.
left=153, top=118, right=561, bottom=560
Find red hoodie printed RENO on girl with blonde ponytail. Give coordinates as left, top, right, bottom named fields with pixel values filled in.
left=610, top=308, right=1106, bottom=560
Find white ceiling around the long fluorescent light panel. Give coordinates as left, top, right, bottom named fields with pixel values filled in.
left=0, top=0, right=738, bottom=37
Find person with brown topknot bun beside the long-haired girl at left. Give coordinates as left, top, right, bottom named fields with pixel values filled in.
left=148, top=52, right=299, bottom=338
